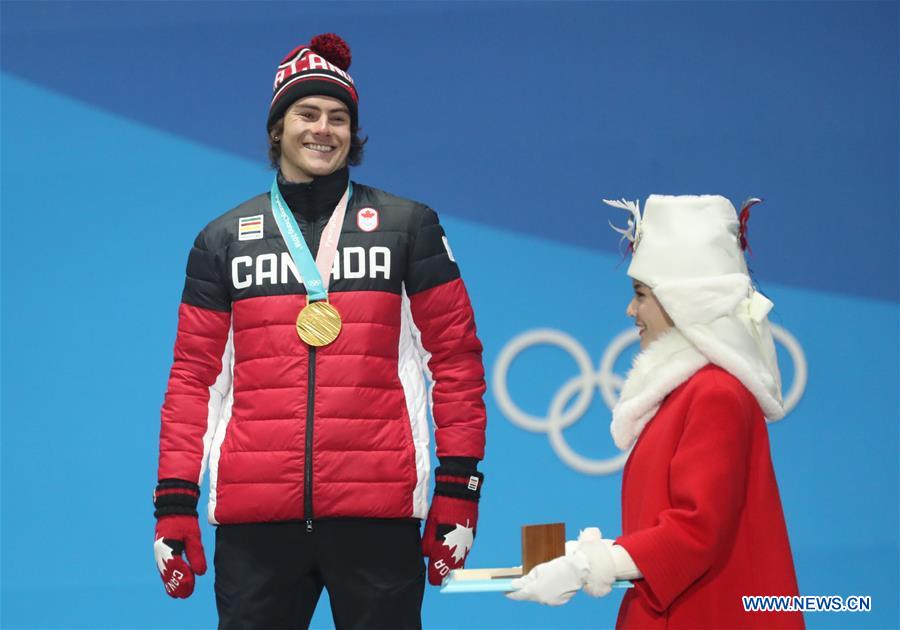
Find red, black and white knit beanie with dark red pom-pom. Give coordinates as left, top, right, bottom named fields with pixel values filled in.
left=266, top=33, right=359, bottom=129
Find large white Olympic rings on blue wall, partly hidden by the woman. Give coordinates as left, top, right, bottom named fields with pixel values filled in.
left=493, top=324, right=807, bottom=475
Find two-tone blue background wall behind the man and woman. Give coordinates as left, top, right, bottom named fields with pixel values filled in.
left=0, top=2, right=900, bottom=628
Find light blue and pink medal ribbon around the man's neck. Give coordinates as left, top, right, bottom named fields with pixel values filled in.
left=270, top=177, right=353, bottom=302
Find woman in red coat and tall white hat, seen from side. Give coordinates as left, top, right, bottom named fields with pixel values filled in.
left=510, top=195, right=803, bottom=628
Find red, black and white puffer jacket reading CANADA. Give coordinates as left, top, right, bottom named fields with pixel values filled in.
left=158, top=175, right=485, bottom=524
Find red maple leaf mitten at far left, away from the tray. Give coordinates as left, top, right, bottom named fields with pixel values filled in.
left=153, top=479, right=206, bottom=599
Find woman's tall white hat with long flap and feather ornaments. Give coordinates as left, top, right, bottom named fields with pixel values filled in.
left=604, top=195, right=784, bottom=420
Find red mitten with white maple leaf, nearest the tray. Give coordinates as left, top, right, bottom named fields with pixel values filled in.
left=422, top=465, right=484, bottom=585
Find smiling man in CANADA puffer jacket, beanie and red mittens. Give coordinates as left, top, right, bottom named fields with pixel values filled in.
left=154, top=34, right=485, bottom=629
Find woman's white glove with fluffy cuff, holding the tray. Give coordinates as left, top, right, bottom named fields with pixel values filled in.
left=506, top=527, right=616, bottom=606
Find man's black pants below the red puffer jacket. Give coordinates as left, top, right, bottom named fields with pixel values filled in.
left=215, top=519, right=425, bottom=630
